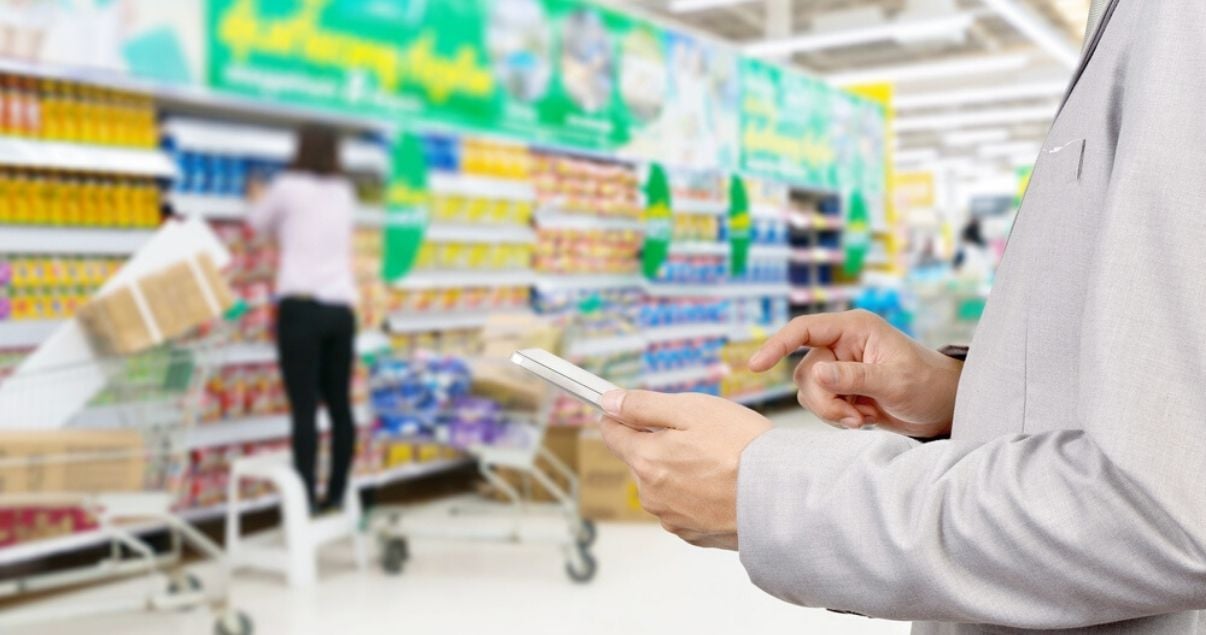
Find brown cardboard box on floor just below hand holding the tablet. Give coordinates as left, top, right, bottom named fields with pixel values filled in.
left=578, top=429, right=656, bottom=522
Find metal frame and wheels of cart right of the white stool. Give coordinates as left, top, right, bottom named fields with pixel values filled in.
left=368, top=351, right=598, bottom=583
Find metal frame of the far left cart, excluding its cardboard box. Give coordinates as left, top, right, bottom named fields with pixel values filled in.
left=0, top=329, right=252, bottom=635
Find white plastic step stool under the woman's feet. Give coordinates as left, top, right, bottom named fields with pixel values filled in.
left=226, top=452, right=368, bottom=587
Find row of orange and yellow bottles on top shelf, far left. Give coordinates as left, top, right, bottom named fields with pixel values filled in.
left=0, top=75, right=159, bottom=148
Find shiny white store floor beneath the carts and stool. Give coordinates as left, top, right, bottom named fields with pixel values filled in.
left=8, top=407, right=908, bottom=635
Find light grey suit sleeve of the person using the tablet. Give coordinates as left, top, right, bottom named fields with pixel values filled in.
left=738, top=0, right=1206, bottom=629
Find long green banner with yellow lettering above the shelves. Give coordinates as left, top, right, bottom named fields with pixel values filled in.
left=204, top=0, right=885, bottom=196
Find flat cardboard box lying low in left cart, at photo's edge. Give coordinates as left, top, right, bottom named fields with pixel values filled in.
left=0, top=430, right=145, bottom=496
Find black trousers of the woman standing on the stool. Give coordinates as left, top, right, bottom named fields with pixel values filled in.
left=276, top=298, right=356, bottom=508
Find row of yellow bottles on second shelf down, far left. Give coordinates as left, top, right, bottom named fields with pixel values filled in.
left=0, top=170, right=160, bottom=228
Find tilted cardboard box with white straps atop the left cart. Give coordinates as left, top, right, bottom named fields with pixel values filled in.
left=80, top=253, right=234, bottom=354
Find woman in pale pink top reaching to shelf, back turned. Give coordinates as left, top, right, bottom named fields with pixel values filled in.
left=248, top=127, right=356, bottom=512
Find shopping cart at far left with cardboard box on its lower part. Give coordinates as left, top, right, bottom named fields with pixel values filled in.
left=0, top=329, right=252, bottom=635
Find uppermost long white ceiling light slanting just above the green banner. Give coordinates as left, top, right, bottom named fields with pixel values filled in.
left=745, top=13, right=976, bottom=55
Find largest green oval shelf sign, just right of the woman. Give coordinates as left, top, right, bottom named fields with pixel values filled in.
left=381, top=133, right=429, bottom=282
